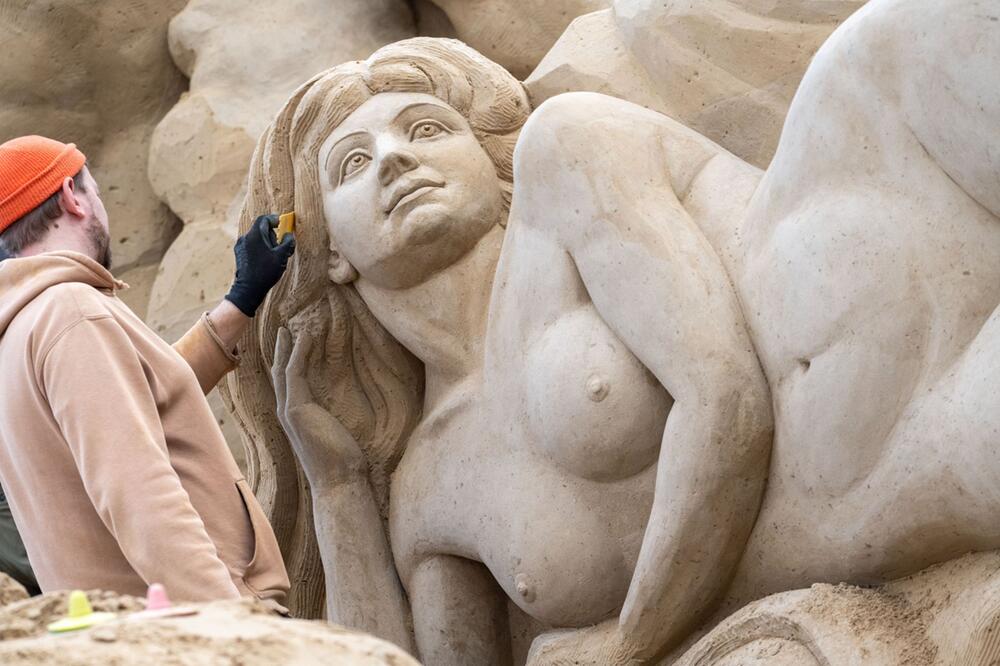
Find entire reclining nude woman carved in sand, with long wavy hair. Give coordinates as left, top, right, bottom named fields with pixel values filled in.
left=235, top=0, right=1000, bottom=665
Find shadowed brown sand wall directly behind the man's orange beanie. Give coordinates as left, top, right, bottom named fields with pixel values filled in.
left=0, top=0, right=186, bottom=315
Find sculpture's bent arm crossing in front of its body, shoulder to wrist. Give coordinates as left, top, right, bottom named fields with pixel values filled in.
left=512, top=96, right=772, bottom=663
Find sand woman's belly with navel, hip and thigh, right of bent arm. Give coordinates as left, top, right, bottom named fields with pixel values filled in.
left=732, top=2, right=1000, bottom=601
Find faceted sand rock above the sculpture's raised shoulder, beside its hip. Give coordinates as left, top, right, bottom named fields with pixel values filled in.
left=525, top=0, right=865, bottom=167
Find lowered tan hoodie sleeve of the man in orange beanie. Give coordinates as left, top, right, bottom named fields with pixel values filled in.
left=40, top=317, right=239, bottom=601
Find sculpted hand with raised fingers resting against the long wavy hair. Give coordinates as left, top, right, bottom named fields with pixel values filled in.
left=271, top=328, right=368, bottom=489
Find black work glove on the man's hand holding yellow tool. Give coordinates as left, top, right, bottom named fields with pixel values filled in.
left=226, top=215, right=295, bottom=317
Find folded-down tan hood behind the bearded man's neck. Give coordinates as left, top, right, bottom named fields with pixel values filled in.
left=0, top=250, right=127, bottom=337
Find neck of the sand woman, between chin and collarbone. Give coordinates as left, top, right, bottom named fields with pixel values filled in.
left=356, top=225, right=504, bottom=404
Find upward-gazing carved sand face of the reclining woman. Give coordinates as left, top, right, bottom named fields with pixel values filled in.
left=319, top=93, right=503, bottom=289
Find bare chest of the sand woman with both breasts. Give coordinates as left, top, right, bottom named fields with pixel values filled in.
left=391, top=229, right=671, bottom=626
